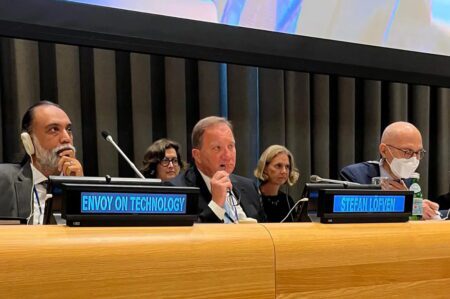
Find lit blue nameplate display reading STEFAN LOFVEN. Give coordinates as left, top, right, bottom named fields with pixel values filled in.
left=333, top=195, right=405, bottom=213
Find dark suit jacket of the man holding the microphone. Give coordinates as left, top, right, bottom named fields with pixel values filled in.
left=170, top=167, right=266, bottom=223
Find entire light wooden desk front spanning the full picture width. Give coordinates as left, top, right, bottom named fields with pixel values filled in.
left=4, top=222, right=450, bottom=299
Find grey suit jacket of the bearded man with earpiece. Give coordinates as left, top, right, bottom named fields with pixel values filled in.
left=0, top=162, right=33, bottom=218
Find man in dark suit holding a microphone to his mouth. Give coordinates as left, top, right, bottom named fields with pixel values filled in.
left=171, top=116, right=265, bottom=223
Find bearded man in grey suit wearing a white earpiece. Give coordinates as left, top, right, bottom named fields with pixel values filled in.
left=0, top=101, right=83, bottom=224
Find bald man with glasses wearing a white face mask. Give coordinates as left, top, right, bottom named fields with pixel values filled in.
left=340, top=121, right=439, bottom=219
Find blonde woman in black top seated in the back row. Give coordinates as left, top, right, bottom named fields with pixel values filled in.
left=254, top=144, right=299, bottom=222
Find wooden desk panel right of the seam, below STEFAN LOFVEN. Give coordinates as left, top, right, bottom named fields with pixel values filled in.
left=265, top=222, right=450, bottom=298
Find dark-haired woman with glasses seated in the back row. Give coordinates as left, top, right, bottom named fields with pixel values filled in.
left=141, top=138, right=184, bottom=181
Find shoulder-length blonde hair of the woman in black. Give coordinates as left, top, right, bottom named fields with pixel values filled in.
left=253, top=144, right=300, bottom=186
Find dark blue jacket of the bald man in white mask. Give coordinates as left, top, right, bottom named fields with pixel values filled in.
left=340, top=161, right=380, bottom=184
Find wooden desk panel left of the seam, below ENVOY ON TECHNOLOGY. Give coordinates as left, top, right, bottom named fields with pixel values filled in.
left=0, top=225, right=275, bottom=299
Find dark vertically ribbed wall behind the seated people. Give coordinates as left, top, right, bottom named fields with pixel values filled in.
left=0, top=38, right=450, bottom=202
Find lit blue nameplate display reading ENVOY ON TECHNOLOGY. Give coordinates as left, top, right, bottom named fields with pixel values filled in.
left=80, top=192, right=187, bottom=214
